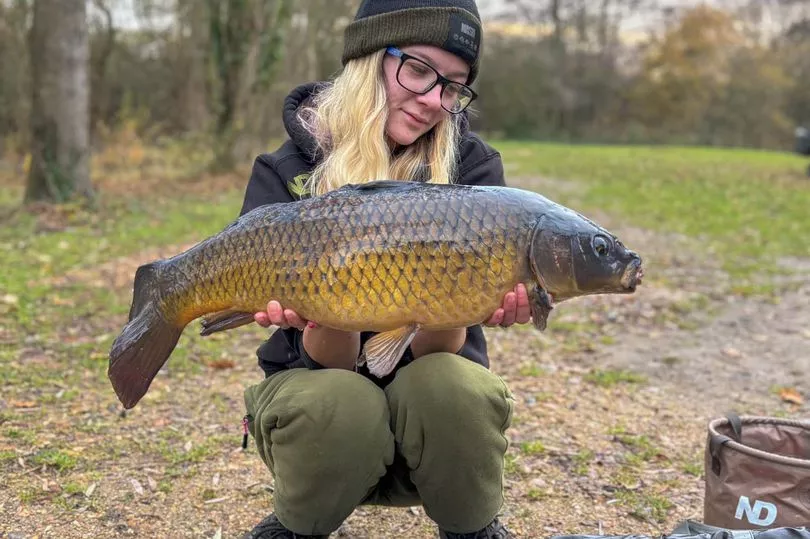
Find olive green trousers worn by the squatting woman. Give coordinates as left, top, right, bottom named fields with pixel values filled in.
left=245, top=353, right=513, bottom=535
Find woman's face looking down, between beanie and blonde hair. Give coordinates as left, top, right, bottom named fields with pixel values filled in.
left=383, top=45, right=470, bottom=146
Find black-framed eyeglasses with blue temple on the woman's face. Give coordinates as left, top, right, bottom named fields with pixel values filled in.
left=385, top=47, right=478, bottom=114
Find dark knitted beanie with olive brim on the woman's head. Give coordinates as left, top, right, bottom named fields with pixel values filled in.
left=343, top=0, right=481, bottom=84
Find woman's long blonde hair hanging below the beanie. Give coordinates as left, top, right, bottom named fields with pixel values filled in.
left=299, top=51, right=459, bottom=195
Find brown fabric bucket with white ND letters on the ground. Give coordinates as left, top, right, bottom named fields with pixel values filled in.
left=703, top=414, right=810, bottom=530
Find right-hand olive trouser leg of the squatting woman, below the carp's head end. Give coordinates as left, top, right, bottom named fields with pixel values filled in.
left=386, top=354, right=513, bottom=533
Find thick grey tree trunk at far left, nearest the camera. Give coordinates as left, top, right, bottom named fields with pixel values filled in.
left=25, top=0, right=94, bottom=202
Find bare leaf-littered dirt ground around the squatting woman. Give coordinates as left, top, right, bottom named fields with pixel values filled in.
left=0, top=178, right=810, bottom=539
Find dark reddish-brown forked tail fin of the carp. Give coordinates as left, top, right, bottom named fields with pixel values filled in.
left=107, top=262, right=183, bottom=409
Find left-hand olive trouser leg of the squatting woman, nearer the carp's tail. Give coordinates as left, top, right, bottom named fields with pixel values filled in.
left=245, top=369, right=394, bottom=534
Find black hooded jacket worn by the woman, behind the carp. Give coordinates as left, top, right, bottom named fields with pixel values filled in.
left=240, top=83, right=504, bottom=387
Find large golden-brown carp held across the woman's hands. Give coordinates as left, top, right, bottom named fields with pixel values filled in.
left=108, top=181, right=642, bottom=408
